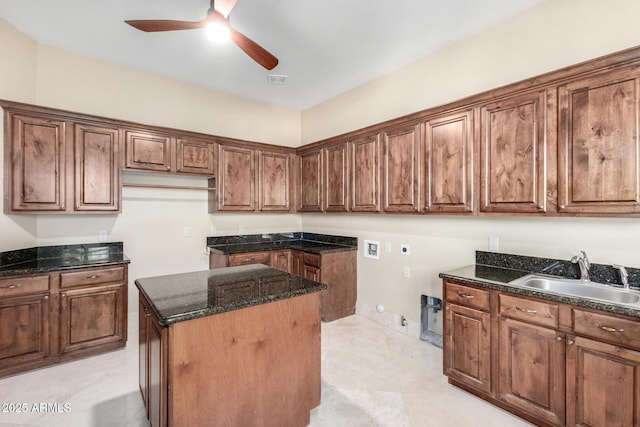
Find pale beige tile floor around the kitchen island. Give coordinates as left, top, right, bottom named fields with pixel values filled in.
left=0, top=315, right=530, bottom=427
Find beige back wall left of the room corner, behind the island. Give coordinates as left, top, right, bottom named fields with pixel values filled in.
left=0, top=19, right=301, bottom=311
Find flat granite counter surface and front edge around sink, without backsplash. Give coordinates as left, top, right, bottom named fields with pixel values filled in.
left=439, top=264, right=640, bottom=318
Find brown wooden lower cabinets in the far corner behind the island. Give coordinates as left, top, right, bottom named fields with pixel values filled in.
left=209, top=249, right=358, bottom=322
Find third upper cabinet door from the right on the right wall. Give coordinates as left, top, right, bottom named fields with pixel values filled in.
left=423, top=111, right=473, bottom=213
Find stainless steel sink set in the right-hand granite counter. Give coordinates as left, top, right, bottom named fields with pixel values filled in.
left=509, top=274, right=640, bottom=306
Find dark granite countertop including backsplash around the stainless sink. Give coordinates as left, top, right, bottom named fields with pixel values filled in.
left=439, top=252, right=640, bottom=318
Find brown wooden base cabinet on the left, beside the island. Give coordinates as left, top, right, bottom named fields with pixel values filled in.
left=0, top=265, right=127, bottom=377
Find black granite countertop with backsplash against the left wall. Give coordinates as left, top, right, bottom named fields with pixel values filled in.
left=0, top=242, right=130, bottom=276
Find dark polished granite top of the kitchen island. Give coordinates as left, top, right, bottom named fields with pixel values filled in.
left=135, top=264, right=327, bottom=326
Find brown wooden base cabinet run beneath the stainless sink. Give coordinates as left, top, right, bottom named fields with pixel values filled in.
left=443, top=280, right=640, bottom=427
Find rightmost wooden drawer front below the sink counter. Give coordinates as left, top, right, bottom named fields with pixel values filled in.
left=573, top=309, right=640, bottom=349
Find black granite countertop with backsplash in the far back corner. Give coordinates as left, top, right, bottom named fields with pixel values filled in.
left=207, top=232, right=358, bottom=255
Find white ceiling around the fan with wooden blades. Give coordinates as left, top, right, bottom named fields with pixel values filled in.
left=0, top=0, right=543, bottom=110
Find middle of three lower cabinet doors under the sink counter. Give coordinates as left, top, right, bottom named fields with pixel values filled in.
left=498, top=317, right=565, bottom=425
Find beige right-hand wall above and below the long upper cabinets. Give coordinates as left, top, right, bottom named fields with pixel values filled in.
left=302, top=0, right=640, bottom=333
